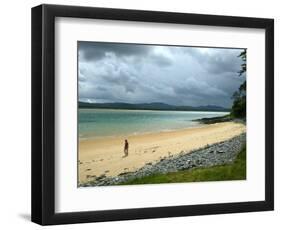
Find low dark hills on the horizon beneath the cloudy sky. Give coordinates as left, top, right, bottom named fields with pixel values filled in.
left=79, top=101, right=230, bottom=112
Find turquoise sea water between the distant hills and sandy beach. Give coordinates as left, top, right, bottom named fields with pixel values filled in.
left=78, top=109, right=228, bottom=139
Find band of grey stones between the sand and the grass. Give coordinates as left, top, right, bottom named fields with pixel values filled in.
left=79, top=133, right=246, bottom=187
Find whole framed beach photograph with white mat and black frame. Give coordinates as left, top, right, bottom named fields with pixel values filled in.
left=32, top=5, right=274, bottom=225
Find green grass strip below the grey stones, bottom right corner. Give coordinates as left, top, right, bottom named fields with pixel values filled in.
left=119, top=145, right=246, bottom=185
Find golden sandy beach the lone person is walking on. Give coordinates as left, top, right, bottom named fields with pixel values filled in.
left=78, top=122, right=246, bottom=184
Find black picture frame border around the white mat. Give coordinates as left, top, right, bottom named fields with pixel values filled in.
left=31, top=5, right=274, bottom=225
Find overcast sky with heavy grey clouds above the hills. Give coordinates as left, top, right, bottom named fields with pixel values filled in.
left=78, top=41, right=245, bottom=107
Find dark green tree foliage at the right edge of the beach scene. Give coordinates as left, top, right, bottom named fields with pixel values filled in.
left=231, top=49, right=247, bottom=118
